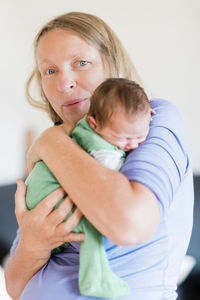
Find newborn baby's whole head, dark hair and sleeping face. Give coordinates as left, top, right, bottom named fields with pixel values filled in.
left=88, top=78, right=154, bottom=151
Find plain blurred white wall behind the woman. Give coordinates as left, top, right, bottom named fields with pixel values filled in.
left=0, top=0, right=200, bottom=185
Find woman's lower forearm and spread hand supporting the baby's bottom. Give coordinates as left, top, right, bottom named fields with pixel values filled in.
left=5, top=181, right=84, bottom=299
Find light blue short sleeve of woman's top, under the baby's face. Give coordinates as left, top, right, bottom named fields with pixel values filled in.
left=121, top=99, right=191, bottom=213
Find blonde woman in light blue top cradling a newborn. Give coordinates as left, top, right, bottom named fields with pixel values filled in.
left=6, top=13, right=193, bottom=300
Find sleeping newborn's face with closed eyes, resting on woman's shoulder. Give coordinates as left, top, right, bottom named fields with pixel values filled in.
left=95, top=110, right=151, bottom=151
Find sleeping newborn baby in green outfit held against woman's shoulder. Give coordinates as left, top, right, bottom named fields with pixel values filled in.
left=26, top=78, right=154, bottom=298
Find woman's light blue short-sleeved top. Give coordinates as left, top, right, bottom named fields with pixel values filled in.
left=11, top=99, right=193, bottom=300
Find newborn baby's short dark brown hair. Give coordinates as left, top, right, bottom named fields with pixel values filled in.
left=88, top=78, right=150, bottom=128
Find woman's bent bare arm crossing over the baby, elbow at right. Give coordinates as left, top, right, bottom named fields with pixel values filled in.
left=28, top=125, right=159, bottom=245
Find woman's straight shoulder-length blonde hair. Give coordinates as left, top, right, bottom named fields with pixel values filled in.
left=26, top=12, right=140, bottom=123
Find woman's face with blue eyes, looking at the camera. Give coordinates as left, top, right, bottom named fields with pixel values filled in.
left=36, top=29, right=110, bottom=122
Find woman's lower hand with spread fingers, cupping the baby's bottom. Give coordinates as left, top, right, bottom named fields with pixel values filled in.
left=15, top=180, right=84, bottom=260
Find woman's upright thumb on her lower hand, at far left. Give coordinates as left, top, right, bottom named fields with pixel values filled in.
left=15, top=179, right=27, bottom=216
